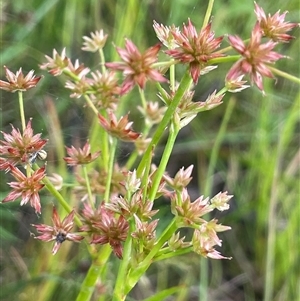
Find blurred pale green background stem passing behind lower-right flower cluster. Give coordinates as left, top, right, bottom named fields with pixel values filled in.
left=199, top=98, right=235, bottom=301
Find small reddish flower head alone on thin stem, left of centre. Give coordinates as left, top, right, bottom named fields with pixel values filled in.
left=64, top=141, right=100, bottom=166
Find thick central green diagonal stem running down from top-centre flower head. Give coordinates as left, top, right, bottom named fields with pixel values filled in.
left=137, top=70, right=192, bottom=177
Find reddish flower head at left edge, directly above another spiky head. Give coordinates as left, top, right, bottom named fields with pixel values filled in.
left=0, top=119, right=48, bottom=165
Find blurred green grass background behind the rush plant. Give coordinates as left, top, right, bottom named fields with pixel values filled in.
left=0, top=0, right=300, bottom=301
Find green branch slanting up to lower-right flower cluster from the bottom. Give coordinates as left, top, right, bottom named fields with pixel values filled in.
left=125, top=218, right=177, bottom=295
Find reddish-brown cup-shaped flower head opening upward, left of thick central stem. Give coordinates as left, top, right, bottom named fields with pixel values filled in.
left=98, top=112, right=140, bottom=142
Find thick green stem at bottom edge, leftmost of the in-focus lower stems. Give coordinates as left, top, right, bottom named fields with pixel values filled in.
left=76, top=244, right=111, bottom=301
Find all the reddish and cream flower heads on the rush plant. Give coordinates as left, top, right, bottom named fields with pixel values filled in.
left=0, top=3, right=299, bottom=260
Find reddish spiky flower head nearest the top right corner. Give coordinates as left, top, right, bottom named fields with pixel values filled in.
left=254, top=2, right=299, bottom=42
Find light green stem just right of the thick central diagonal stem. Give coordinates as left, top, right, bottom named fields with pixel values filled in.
left=149, top=122, right=180, bottom=202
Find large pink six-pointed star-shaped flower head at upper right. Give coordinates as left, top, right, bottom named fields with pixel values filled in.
left=226, top=23, right=283, bottom=91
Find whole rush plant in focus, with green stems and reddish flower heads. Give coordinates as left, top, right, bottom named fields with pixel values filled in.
left=0, top=3, right=300, bottom=301
